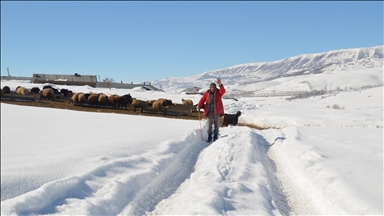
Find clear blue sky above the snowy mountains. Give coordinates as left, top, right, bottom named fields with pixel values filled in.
left=1, top=1, right=384, bottom=83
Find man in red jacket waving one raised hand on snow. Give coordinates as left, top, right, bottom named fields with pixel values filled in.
left=196, top=78, right=225, bottom=142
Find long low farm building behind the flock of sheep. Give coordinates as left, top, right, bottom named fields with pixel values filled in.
left=32, top=73, right=97, bottom=87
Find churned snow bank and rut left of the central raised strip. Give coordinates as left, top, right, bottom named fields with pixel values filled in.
left=1, top=130, right=206, bottom=215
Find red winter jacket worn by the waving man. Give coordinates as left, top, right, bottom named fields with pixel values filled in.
left=197, top=84, right=225, bottom=117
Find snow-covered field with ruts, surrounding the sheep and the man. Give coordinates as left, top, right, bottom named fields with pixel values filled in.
left=1, top=81, right=383, bottom=215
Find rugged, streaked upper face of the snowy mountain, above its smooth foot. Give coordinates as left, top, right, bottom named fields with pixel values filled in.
left=151, top=45, right=384, bottom=91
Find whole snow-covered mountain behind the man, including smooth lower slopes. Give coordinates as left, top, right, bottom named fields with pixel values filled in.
left=152, top=45, right=384, bottom=94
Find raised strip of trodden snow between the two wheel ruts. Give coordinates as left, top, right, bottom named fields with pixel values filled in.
left=149, top=126, right=290, bottom=215
